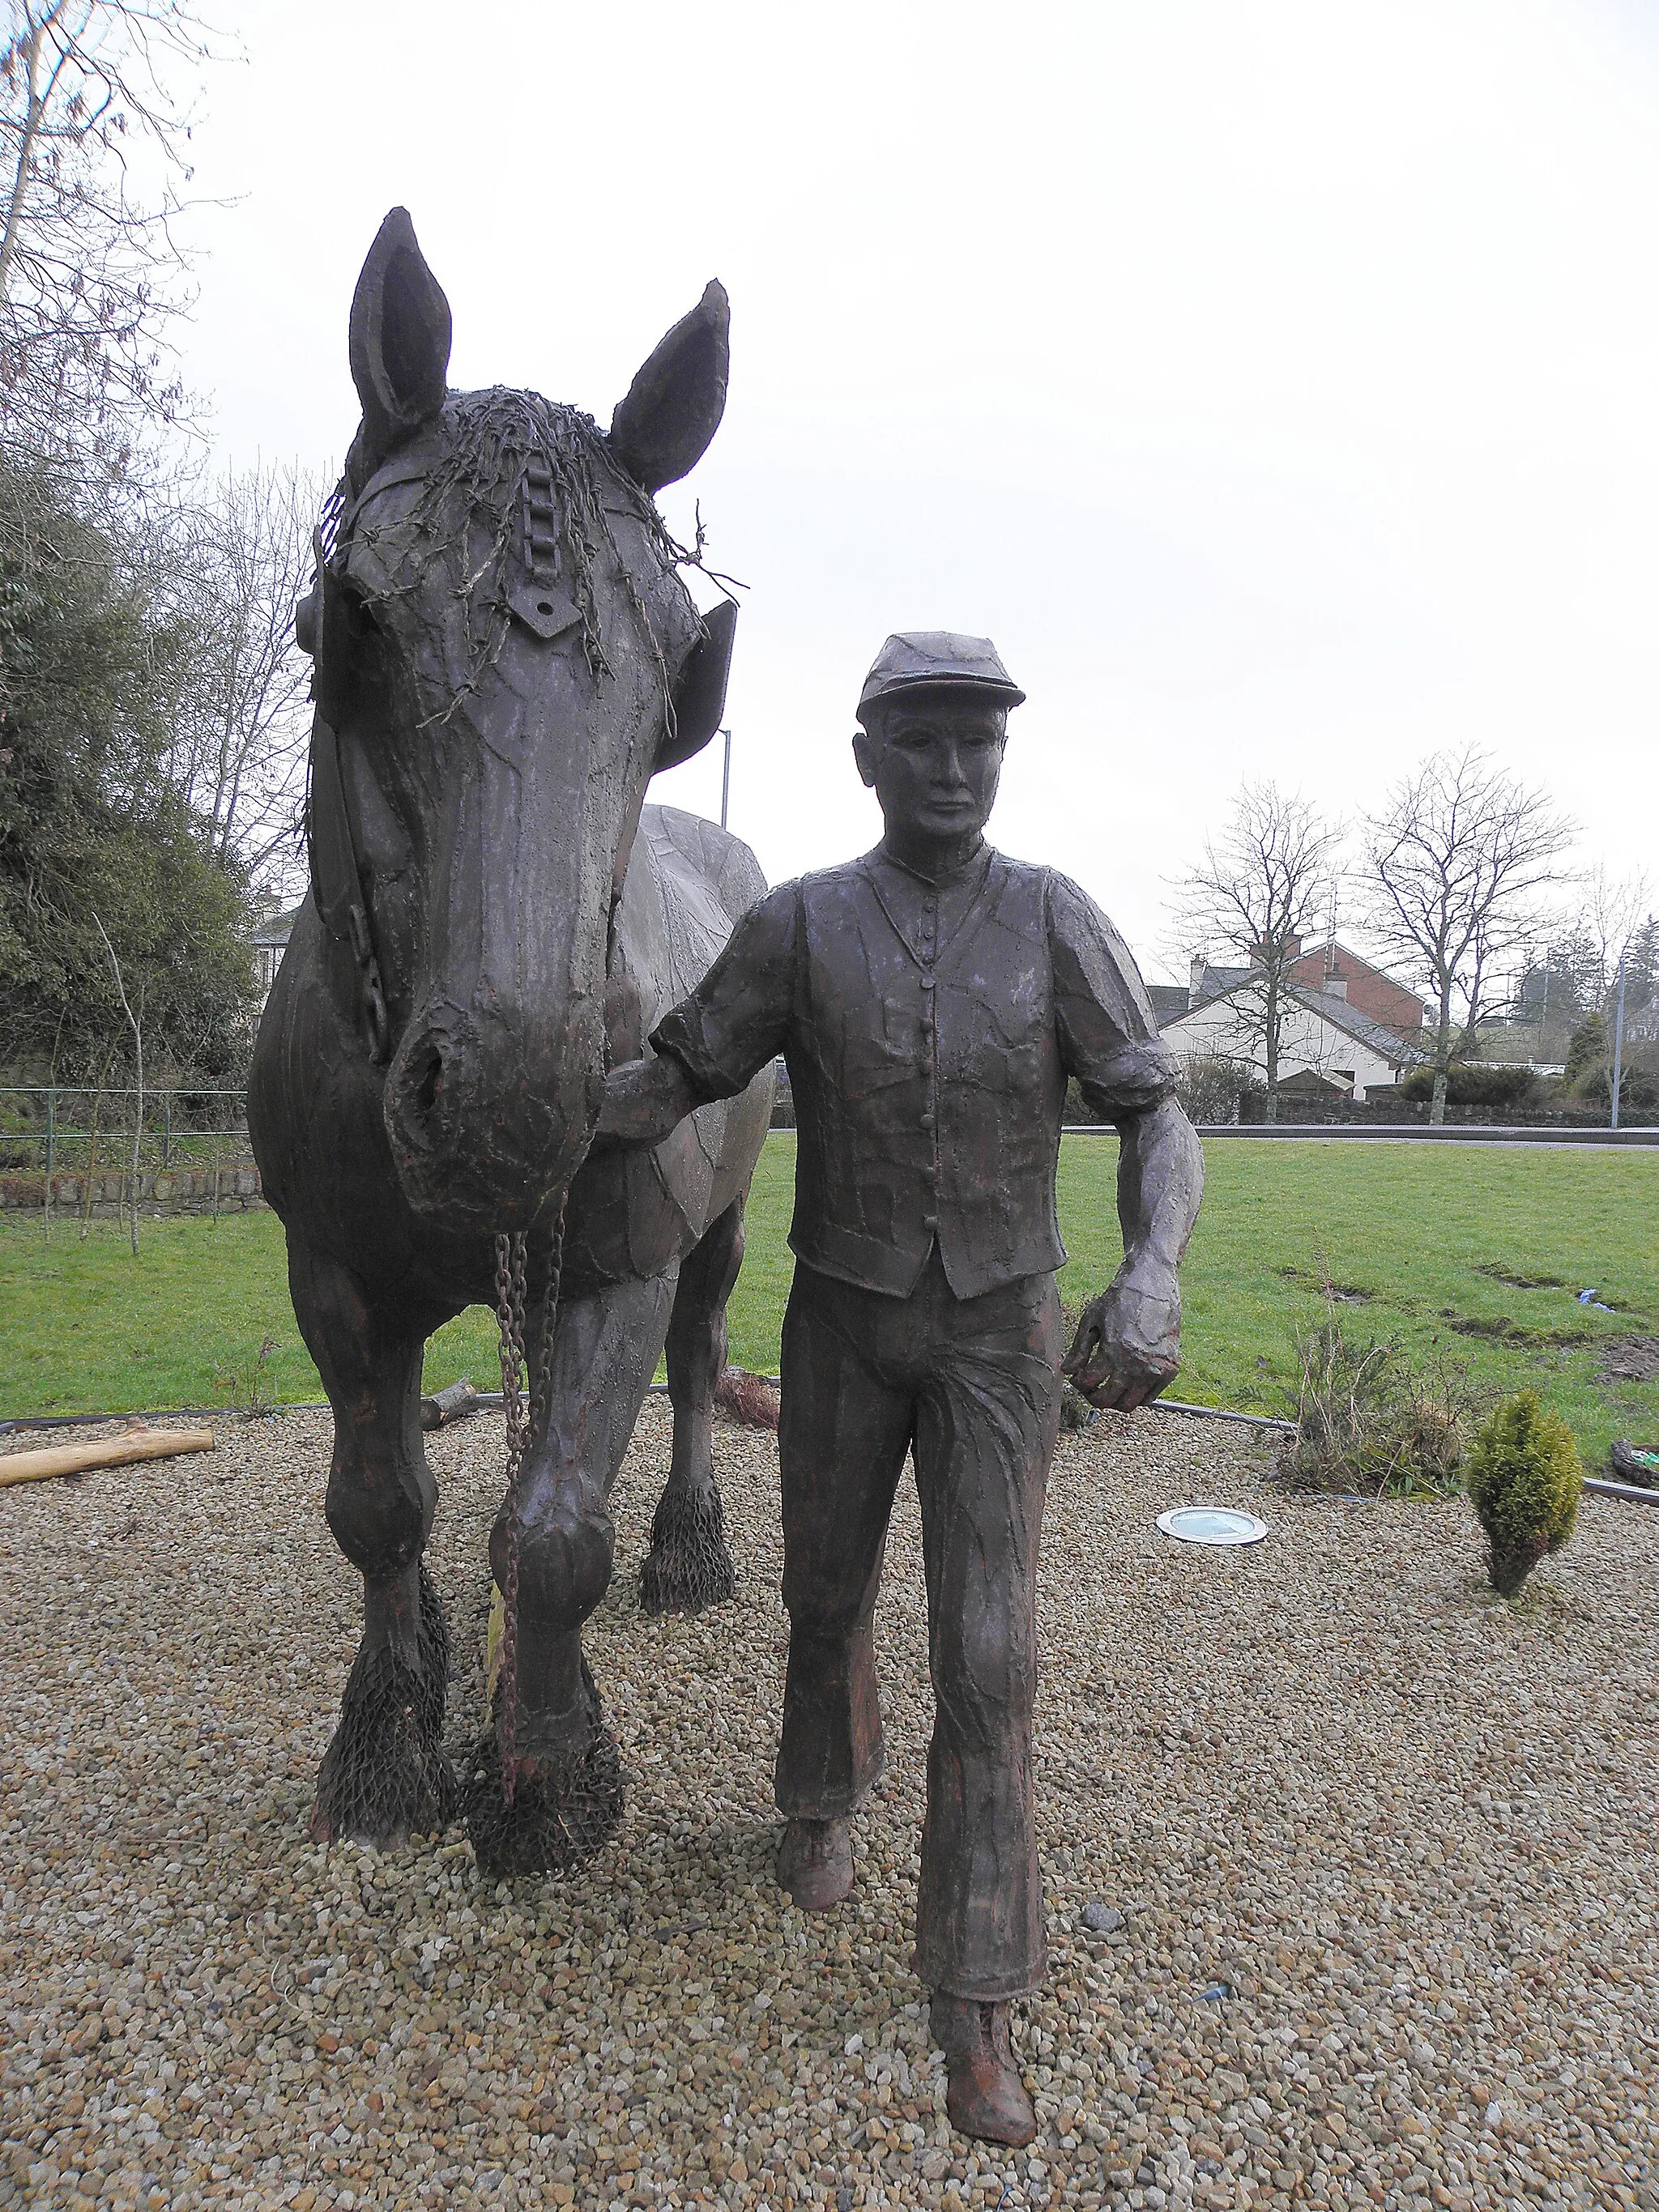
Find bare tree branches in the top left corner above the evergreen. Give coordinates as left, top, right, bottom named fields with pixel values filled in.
left=0, top=0, right=234, bottom=480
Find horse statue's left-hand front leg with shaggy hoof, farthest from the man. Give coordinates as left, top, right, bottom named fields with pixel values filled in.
left=288, top=1230, right=456, bottom=1849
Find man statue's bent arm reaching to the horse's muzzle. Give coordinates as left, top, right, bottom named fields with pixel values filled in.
left=595, top=883, right=799, bottom=1146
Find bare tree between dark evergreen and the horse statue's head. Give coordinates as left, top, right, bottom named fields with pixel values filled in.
left=151, top=462, right=323, bottom=889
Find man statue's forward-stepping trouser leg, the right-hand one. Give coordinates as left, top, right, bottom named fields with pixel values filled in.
left=915, top=1279, right=1060, bottom=2000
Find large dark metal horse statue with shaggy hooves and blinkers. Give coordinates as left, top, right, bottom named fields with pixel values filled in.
left=248, top=208, right=772, bottom=1873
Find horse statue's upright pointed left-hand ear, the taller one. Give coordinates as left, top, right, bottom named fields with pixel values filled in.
left=348, top=208, right=451, bottom=489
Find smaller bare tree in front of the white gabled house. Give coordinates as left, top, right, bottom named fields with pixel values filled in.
left=1175, top=783, right=1343, bottom=1122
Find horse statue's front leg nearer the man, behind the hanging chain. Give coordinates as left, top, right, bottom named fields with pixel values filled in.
left=467, top=1268, right=675, bottom=1878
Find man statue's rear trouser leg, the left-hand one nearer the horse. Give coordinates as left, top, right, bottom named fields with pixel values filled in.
left=776, top=1268, right=911, bottom=1821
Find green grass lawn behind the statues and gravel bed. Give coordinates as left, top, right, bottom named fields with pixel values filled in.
left=0, top=1132, right=1659, bottom=1467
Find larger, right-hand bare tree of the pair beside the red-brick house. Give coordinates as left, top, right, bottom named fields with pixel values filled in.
left=1367, top=745, right=1575, bottom=1122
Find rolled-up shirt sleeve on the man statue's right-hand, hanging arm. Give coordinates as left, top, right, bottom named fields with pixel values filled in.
left=1048, top=874, right=1175, bottom=1122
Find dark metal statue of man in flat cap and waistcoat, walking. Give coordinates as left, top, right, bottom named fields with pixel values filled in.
left=599, top=633, right=1203, bottom=2143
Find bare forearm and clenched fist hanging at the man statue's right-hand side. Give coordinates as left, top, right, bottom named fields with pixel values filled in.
left=1064, top=1097, right=1203, bottom=1411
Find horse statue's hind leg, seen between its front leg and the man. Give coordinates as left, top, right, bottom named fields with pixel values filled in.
left=639, top=1196, right=744, bottom=1613
